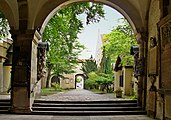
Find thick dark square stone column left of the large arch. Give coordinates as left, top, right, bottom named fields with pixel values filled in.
left=11, top=30, right=35, bottom=113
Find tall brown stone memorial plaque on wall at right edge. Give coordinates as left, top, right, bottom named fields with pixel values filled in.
left=158, top=15, right=171, bottom=89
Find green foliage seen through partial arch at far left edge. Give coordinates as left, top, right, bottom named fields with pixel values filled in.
left=0, top=11, right=10, bottom=38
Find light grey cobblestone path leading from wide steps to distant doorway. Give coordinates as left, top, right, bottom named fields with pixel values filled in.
left=41, top=89, right=114, bottom=101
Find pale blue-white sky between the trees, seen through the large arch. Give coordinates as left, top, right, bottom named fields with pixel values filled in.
left=78, top=5, right=123, bottom=59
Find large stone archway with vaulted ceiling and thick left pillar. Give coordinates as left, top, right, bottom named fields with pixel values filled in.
left=0, top=0, right=149, bottom=113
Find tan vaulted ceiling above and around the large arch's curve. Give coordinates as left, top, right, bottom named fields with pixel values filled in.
left=0, top=0, right=150, bottom=31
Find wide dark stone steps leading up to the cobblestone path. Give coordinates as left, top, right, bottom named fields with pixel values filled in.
left=32, top=100, right=146, bottom=116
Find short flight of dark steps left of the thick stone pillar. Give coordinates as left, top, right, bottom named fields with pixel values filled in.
left=0, top=99, right=11, bottom=114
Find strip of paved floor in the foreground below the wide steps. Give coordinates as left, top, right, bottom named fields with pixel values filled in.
left=0, top=114, right=154, bottom=120
